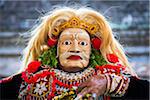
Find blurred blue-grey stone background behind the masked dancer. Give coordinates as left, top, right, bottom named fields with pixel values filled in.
left=0, top=0, right=150, bottom=79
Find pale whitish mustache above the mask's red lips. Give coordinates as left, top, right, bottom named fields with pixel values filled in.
left=60, top=52, right=89, bottom=60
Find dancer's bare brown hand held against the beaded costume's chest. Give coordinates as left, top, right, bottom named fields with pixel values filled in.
left=77, top=75, right=107, bottom=99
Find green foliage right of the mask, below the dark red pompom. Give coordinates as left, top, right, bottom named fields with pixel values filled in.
left=90, top=48, right=107, bottom=67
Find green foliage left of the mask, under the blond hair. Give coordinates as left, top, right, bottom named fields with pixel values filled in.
left=38, top=46, right=58, bottom=68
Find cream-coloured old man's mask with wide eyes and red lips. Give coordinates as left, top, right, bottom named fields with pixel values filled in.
left=57, top=28, right=91, bottom=72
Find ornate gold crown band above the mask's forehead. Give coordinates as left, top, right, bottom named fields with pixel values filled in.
left=52, top=17, right=99, bottom=36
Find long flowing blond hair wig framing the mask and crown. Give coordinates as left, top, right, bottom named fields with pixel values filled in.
left=21, top=7, right=135, bottom=75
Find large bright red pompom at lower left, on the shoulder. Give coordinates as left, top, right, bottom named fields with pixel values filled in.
left=27, top=61, right=41, bottom=73
